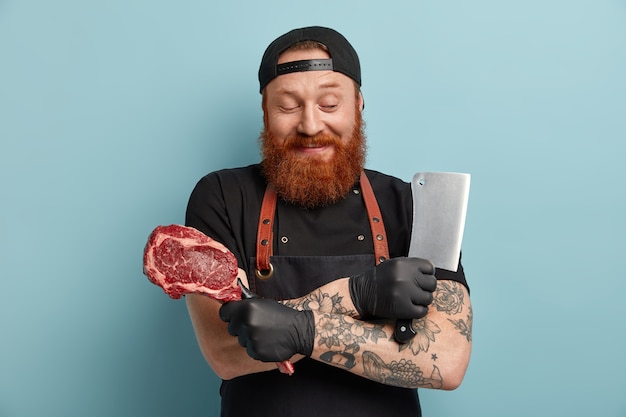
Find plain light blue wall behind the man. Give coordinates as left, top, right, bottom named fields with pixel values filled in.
left=0, top=0, right=626, bottom=417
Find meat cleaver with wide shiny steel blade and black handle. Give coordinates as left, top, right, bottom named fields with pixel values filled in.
left=394, top=172, right=470, bottom=343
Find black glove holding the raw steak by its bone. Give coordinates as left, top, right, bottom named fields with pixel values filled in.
left=220, top=298, right=315, bottom=362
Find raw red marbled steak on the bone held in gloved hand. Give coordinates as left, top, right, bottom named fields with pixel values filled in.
left=143, top=224, right=294, bottom=375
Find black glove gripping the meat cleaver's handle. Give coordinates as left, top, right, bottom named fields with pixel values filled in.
left=349, top=258, right=437, bottom=319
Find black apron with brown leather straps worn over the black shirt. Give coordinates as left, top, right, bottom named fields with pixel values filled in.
left=220, top=173, right=421, bottom=417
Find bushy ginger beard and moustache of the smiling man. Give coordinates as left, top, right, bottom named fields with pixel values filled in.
left=260, top=106, right=366, bottom=209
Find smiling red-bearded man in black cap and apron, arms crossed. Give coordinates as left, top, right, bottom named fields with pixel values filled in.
left=186, top=27, right=472, bottom=417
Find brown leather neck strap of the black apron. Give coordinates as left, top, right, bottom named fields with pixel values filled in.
left=255, top=171, right=389, bottom=279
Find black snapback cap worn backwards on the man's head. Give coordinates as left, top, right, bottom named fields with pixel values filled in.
left=259, top=26, right=361, bottom=92
